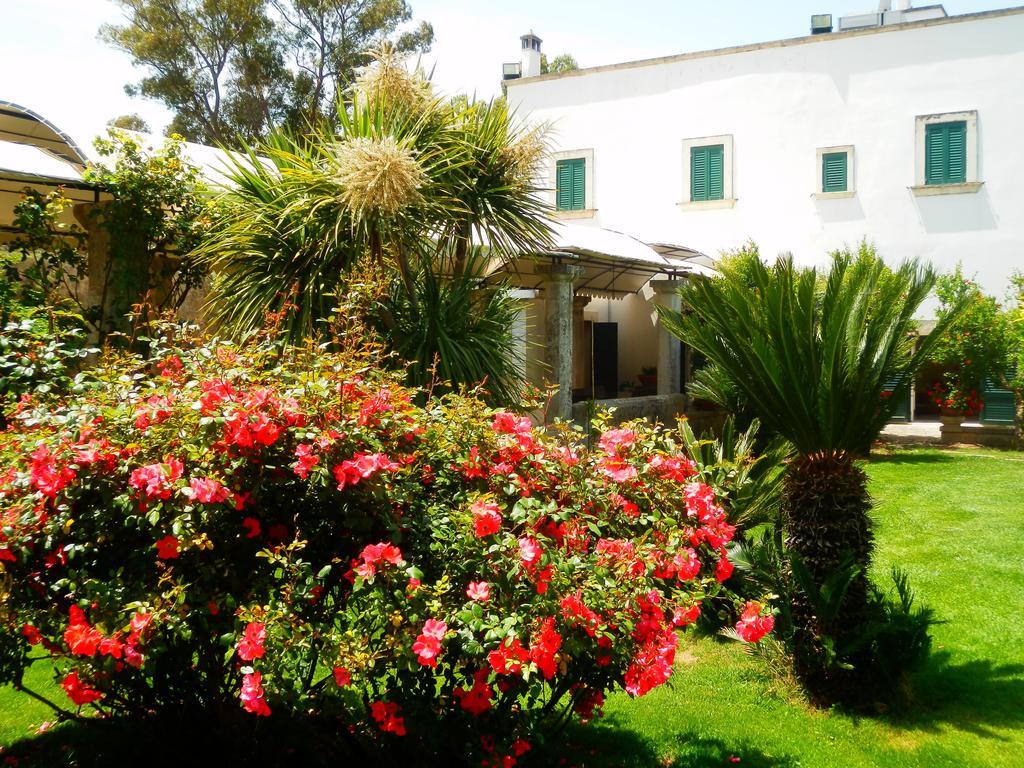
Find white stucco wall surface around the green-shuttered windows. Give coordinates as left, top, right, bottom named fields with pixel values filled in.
left=508, top=9, right=1024, bottom=309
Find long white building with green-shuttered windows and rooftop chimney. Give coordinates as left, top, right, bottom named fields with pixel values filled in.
left=506, top=0, right=1024, bottom=421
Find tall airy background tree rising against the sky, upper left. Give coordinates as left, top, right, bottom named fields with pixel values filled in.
left=100, top=0, right=433, bottom=145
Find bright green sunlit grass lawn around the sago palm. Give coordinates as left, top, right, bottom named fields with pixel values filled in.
left=0, top=449, right=1024, bottom=768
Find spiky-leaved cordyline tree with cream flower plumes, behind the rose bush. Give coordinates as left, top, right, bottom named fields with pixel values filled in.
left=197, top=48, right=550, bottom=399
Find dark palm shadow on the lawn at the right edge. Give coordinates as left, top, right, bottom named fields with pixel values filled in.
left=884, top=651, right=1024, bottom=740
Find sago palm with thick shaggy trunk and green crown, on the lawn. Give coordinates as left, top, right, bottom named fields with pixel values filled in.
left=658, top=252, right=962, bottom=703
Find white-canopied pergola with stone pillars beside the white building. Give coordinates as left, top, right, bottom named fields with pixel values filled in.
left=493, top=222, right=715, bottom=420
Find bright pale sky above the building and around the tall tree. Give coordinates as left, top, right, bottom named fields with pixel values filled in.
left=0, top=0, right=1014, bottom=147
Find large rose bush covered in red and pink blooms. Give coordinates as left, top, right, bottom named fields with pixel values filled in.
left=0, top=327, right=772, bottom=766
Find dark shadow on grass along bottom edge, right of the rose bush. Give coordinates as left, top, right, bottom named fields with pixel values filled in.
left=552, top=716, right=799, bottom=768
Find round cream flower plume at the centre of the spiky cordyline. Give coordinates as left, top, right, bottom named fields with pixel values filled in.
left=334, top=136, right=426, bottom=216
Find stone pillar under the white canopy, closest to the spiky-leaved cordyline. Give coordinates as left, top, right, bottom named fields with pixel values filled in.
left=537, top=264, right=583, bottom=421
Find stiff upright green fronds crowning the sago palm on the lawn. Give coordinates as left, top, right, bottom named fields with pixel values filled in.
left=658, top=253, right=962, bottom=454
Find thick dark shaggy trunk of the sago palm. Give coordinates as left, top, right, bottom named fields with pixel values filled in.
left=784, top=452, right=873, bottom=706
